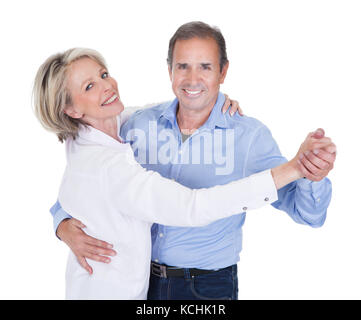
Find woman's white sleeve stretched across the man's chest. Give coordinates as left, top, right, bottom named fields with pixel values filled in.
left=102, top=149, right=277, bottom=226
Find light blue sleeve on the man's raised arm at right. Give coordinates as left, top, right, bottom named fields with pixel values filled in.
left=247, top=126, right=332, bottom=227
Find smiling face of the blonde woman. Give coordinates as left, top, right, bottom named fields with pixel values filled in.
left=65, top=58, right=124, bottom=124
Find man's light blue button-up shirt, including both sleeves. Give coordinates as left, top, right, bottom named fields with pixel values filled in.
left=51, top=93, right=331, bottom=269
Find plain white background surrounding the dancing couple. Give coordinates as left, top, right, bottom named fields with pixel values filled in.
left=0, top=0, right=361, bottom=299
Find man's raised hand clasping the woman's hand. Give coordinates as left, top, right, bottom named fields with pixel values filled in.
left=297, top=129, right=336, bottom=181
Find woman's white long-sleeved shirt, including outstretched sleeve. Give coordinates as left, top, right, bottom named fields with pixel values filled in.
left=59, top=113, right=277, bottom=299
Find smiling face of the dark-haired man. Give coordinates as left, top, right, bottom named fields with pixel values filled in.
left=168, top=38, right=228, bottom=111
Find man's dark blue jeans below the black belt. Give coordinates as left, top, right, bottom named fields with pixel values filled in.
left=148, top=264, right=238, bottom=300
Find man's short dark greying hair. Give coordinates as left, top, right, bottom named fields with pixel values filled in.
left=167, top=21, right=228, bottom=72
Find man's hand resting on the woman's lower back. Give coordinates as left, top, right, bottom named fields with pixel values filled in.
left=56, top=218, right=116, bottom=274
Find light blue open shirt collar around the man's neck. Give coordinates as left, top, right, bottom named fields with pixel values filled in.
left=160, top=92, right=229, bottom=129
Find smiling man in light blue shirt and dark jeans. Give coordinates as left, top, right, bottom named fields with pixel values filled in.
left=52, top=22, right=335, bottom=299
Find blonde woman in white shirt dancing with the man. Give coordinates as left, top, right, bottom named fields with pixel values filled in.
left=34, top=49, right=328, bottom=299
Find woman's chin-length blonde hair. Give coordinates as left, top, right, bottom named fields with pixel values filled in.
left=33, top=48, right=106, bottom=142
